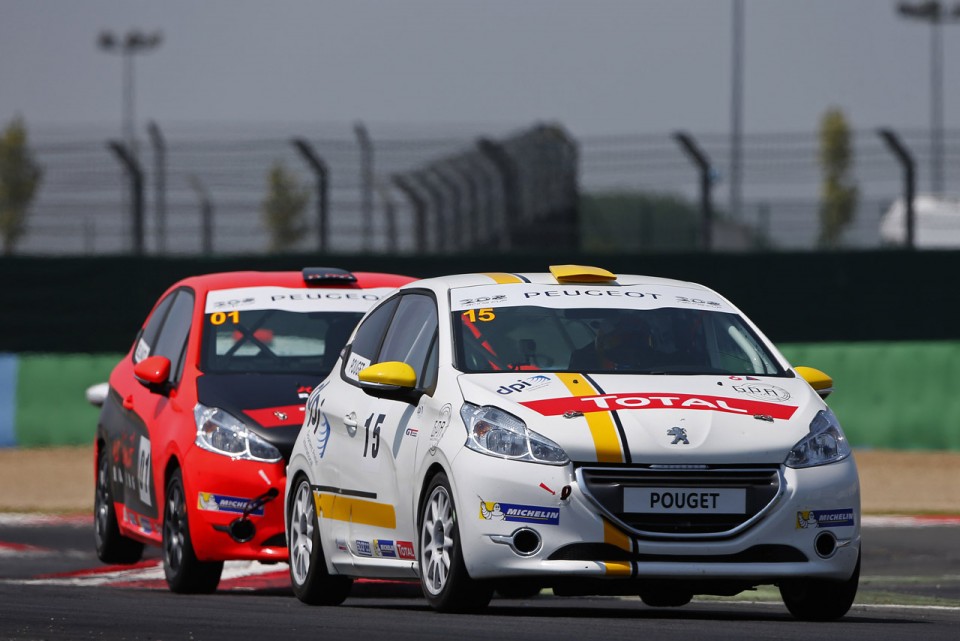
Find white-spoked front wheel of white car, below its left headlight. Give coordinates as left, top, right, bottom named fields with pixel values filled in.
left=419, top=472, right=494, bottom=613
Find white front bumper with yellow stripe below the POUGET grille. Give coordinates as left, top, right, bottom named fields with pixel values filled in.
left=451, top=450, right=860, bottom=585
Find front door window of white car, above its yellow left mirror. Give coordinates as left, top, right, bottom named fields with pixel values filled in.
left=377, top=294, right=438, bottom=387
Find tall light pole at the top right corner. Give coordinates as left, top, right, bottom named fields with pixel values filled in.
left=897, top=0, right=960, bottom=194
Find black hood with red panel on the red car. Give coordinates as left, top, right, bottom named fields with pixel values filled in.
left=197, top=374, right=322, bottom=460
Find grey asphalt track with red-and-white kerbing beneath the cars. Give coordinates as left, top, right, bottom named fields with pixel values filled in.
left=0, top=515, right=960, bottom=641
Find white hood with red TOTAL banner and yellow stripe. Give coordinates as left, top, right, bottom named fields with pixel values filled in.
left=459, top=372, right=826, bottom=464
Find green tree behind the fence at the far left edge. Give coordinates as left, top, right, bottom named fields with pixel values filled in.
left=0, top=116, right=43, bottom=255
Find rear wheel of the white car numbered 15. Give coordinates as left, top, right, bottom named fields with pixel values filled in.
left=287, top=476, right=353, bottom=605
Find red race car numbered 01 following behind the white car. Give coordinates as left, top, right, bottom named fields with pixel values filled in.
left=94, top=268, right=413, bottom=592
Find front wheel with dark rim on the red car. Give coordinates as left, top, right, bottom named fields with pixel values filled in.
left=163, top=469, right=223, bottom=594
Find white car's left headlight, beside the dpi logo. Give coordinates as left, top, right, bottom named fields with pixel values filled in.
left=460, top=403, right=570, bottom=465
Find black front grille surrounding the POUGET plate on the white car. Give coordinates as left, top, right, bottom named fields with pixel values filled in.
left=577, top=466, right=782, bottom=539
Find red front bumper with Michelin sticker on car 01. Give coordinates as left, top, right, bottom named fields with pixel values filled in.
left=183, top=447, right=288, bottom=561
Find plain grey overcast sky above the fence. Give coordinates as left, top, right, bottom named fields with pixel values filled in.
left=0, top=0, right=960, bottom=136
